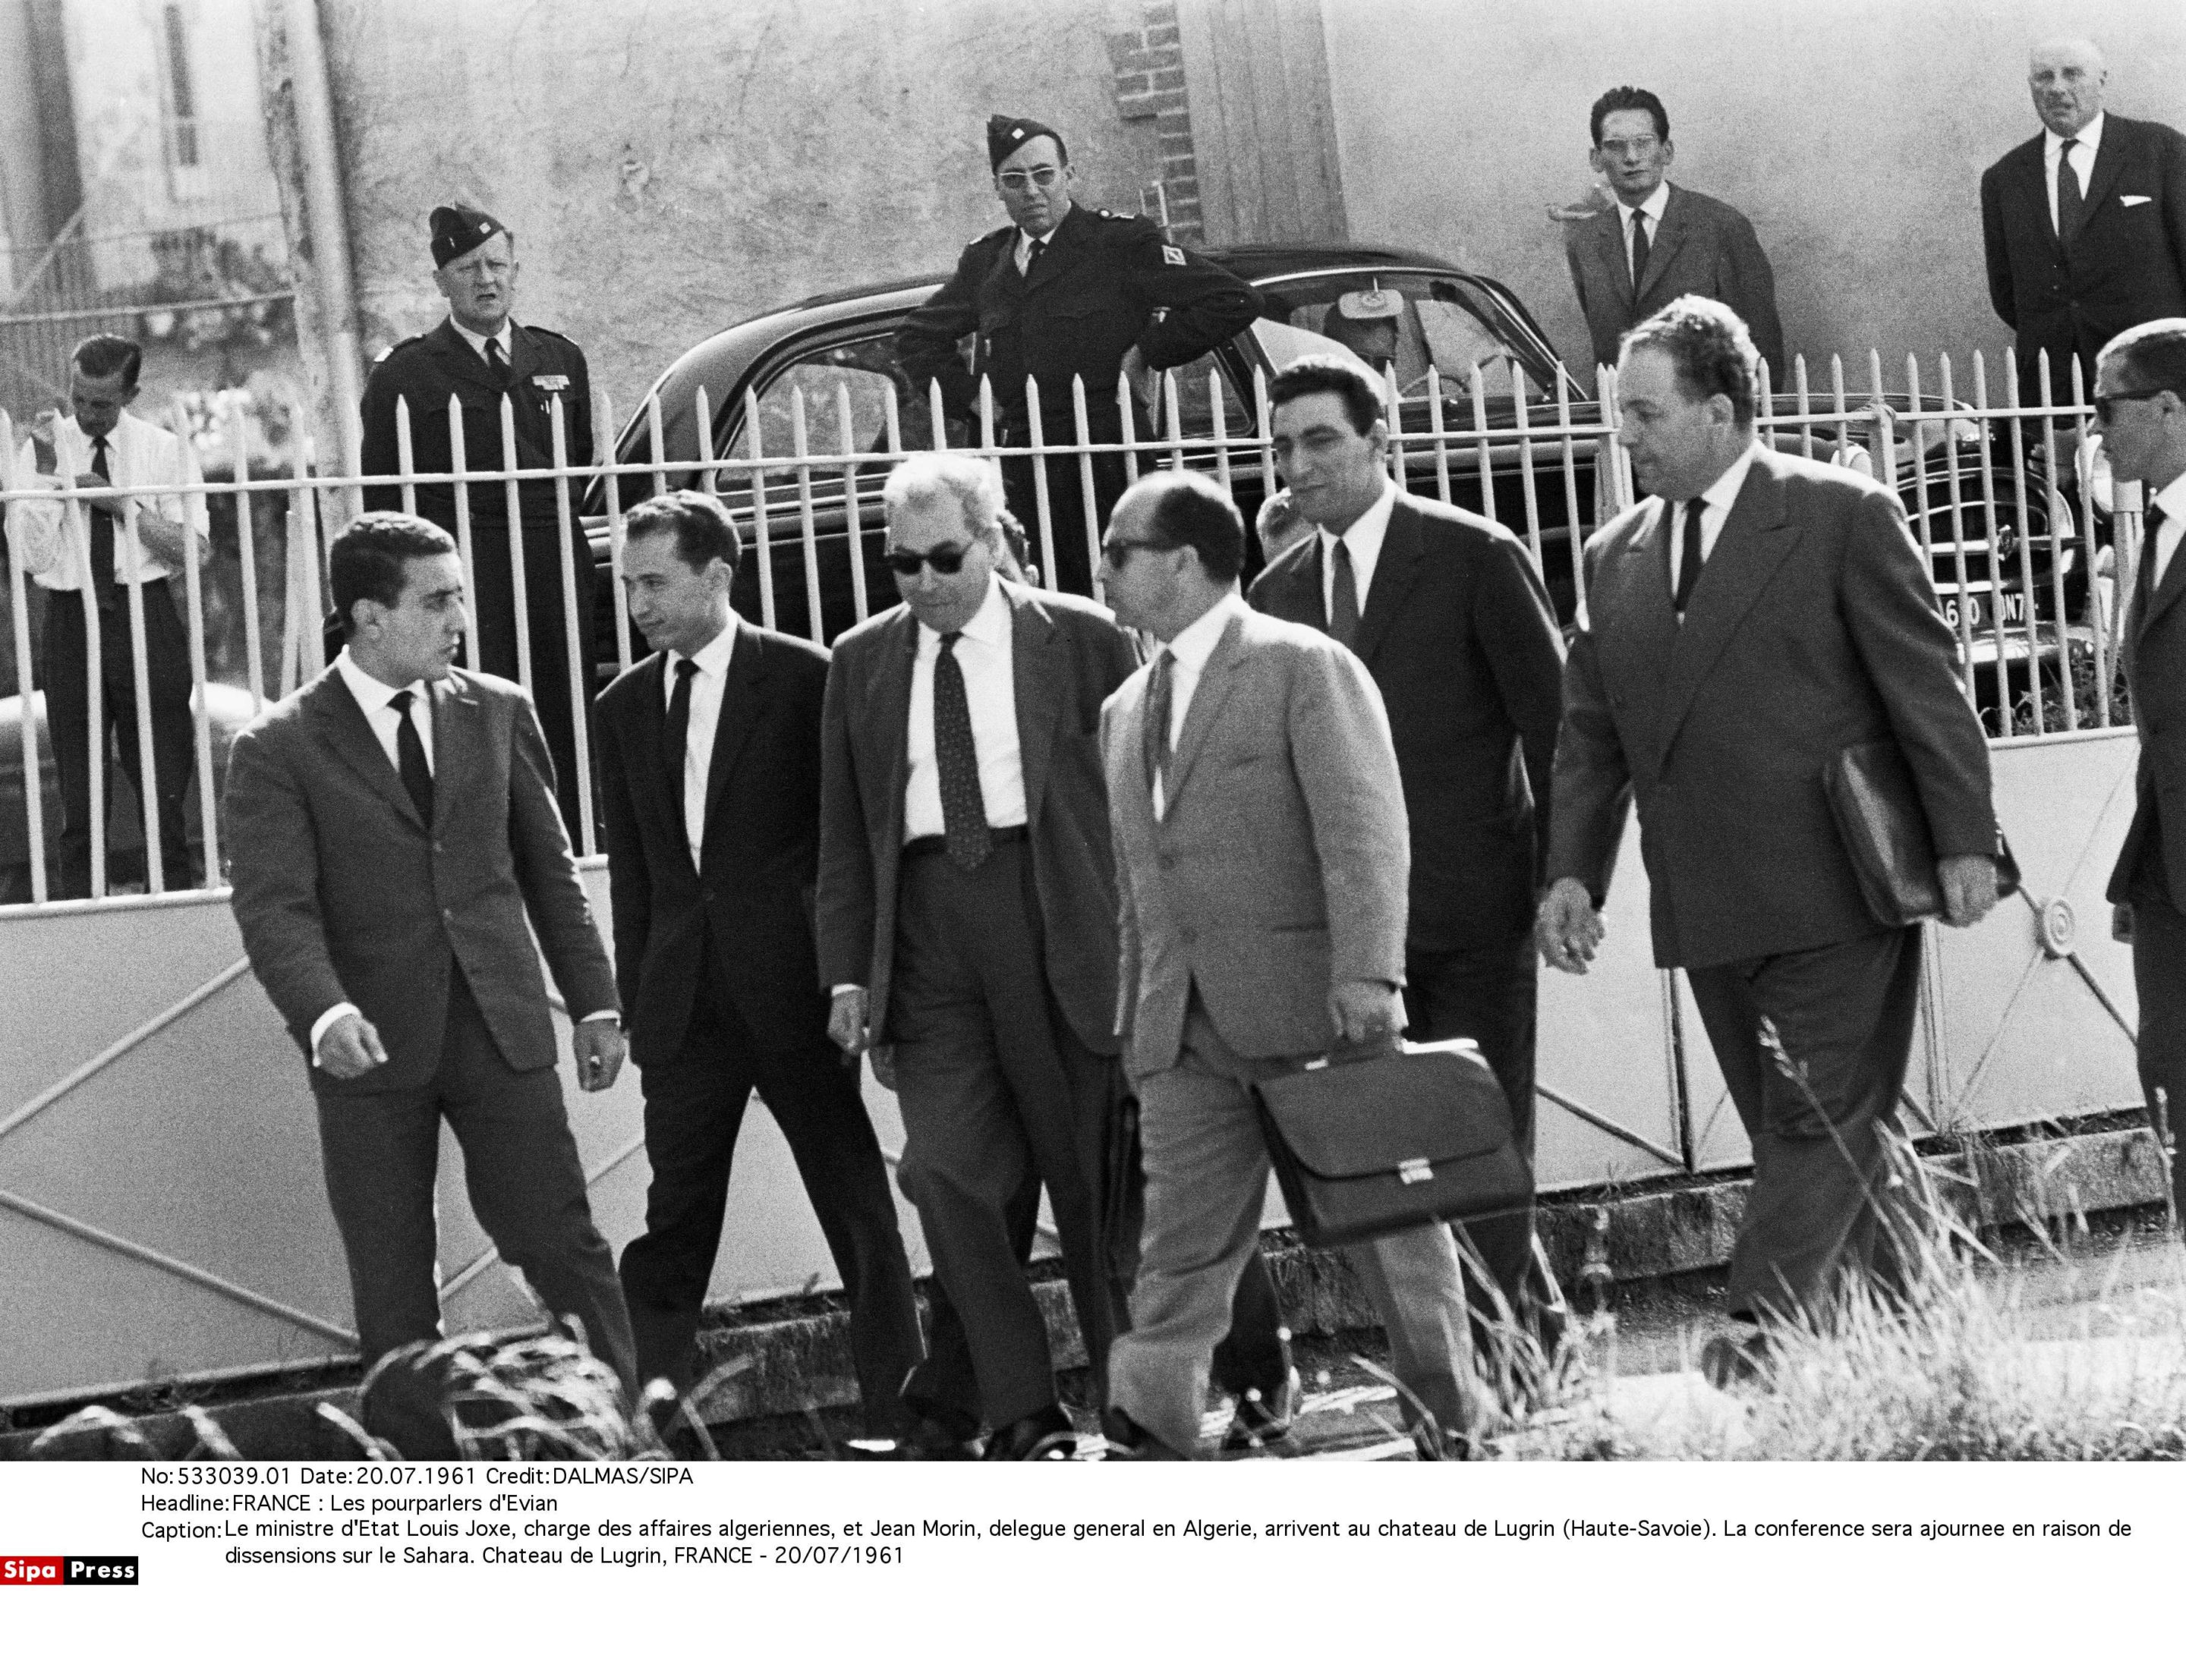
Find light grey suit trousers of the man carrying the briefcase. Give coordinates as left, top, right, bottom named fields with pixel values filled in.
left=1108, top=994, right=1476, bottom=1453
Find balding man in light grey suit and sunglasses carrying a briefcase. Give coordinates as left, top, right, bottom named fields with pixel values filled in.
left=1100, top=472, right=1476, bottom=1457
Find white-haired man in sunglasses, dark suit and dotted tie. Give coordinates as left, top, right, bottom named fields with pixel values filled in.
left=817, top=455, right=1137, bottom=1459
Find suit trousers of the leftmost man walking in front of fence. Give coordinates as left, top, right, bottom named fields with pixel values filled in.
left=313, top=964, right=636, bottom=1394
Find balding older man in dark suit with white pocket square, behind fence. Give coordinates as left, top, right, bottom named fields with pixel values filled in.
left=1980, top=39, right=2186, bottom=402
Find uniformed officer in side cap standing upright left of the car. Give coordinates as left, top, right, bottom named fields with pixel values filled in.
left=363, top=203, right=597, bottom=857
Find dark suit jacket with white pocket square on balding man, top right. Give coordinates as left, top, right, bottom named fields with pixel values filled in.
left=1980, top=112, right=2186, bottom=389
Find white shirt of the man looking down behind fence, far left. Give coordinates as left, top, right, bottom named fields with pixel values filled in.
left=7, top=411, right=212, bottom=592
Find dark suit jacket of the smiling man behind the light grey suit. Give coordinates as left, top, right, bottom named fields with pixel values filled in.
left=1250, top=492, right=1563, bottom=950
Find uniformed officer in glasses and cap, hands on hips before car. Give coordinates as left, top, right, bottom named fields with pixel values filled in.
left=896, top=116, right=1259, bottom=594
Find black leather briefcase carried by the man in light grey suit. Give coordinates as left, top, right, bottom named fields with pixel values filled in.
left=1257, top=1038, right=1532, bottom=1247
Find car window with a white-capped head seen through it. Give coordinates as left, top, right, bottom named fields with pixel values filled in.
left=1252, top=269, right=1548, bottom=404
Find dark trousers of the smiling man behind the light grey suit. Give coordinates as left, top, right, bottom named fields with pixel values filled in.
left=1403, top=943, right=1565, bottom=1352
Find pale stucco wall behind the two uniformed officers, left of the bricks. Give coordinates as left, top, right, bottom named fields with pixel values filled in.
left=321, top=0, right=1161, bottom=413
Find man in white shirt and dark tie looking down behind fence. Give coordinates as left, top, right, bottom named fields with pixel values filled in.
left=7, top=332, right=208, bottom=898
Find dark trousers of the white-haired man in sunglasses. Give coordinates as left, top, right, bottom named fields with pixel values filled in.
left=887, top=841, right=1115, bottom=1429
